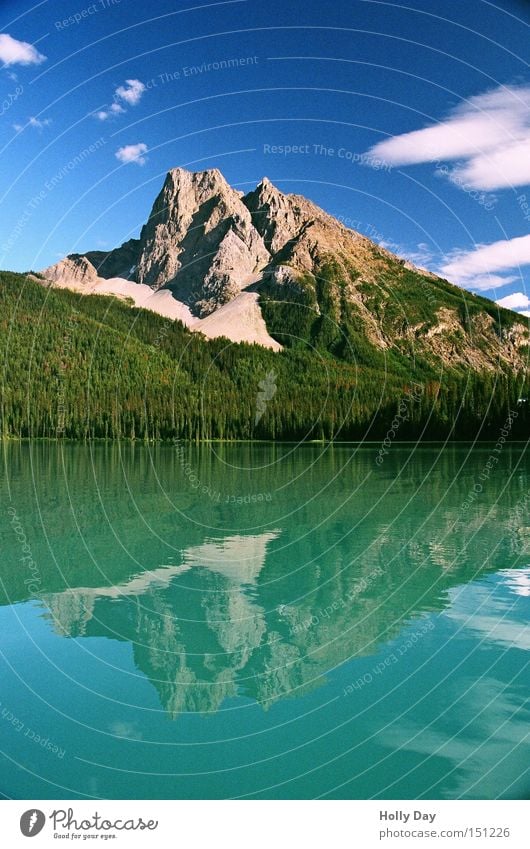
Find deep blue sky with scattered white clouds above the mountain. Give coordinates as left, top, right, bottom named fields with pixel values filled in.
left=0, top=0, right=530, bottom=313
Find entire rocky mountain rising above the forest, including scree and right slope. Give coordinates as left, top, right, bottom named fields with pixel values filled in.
left=43, top=168, right=528, bottom=364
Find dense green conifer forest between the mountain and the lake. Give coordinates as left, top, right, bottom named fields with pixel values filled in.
left=0, top=272, right=528, bottom=440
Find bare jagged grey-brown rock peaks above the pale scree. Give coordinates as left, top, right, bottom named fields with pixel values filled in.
left=42, top=168, right=338, bottom=318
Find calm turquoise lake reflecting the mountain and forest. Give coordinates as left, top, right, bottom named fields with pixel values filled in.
left=0, top=444, right=530, bottom=799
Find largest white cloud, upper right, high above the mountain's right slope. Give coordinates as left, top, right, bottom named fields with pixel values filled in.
left=369, top=86, right=530, bottom=191
